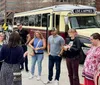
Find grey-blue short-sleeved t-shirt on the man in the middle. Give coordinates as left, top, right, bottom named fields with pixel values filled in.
left=48, top=35, right=65, bottom=56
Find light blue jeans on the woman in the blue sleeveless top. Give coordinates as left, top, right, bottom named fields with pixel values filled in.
left=31, top=54, right=43, bottom=76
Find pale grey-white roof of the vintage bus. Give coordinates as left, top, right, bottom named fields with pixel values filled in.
left=15, top=4, right=96, bottom=14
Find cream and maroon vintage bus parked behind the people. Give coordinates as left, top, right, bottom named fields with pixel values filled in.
left=14, top=4, right=100, bottom=63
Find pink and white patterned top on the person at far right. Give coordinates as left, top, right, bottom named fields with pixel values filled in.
left=82, top=47, right=100, bottom=80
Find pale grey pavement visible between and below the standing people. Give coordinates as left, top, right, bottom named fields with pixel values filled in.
left=22, top=53, right=83, bottom=85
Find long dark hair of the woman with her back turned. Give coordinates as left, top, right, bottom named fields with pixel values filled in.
left=8, top=31, right=20, bottom=47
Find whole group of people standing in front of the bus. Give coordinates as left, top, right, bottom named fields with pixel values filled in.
left=0, top=24, right=100, bottom=85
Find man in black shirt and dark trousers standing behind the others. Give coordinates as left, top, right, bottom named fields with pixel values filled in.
left=17, top=23, right=29, bottom=72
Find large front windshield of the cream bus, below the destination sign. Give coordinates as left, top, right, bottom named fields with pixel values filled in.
left=69, top=16, right=100, bottom=29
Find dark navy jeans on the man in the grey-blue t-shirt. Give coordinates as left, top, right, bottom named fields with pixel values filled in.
left=48, top=55, right=62, bottom=81
